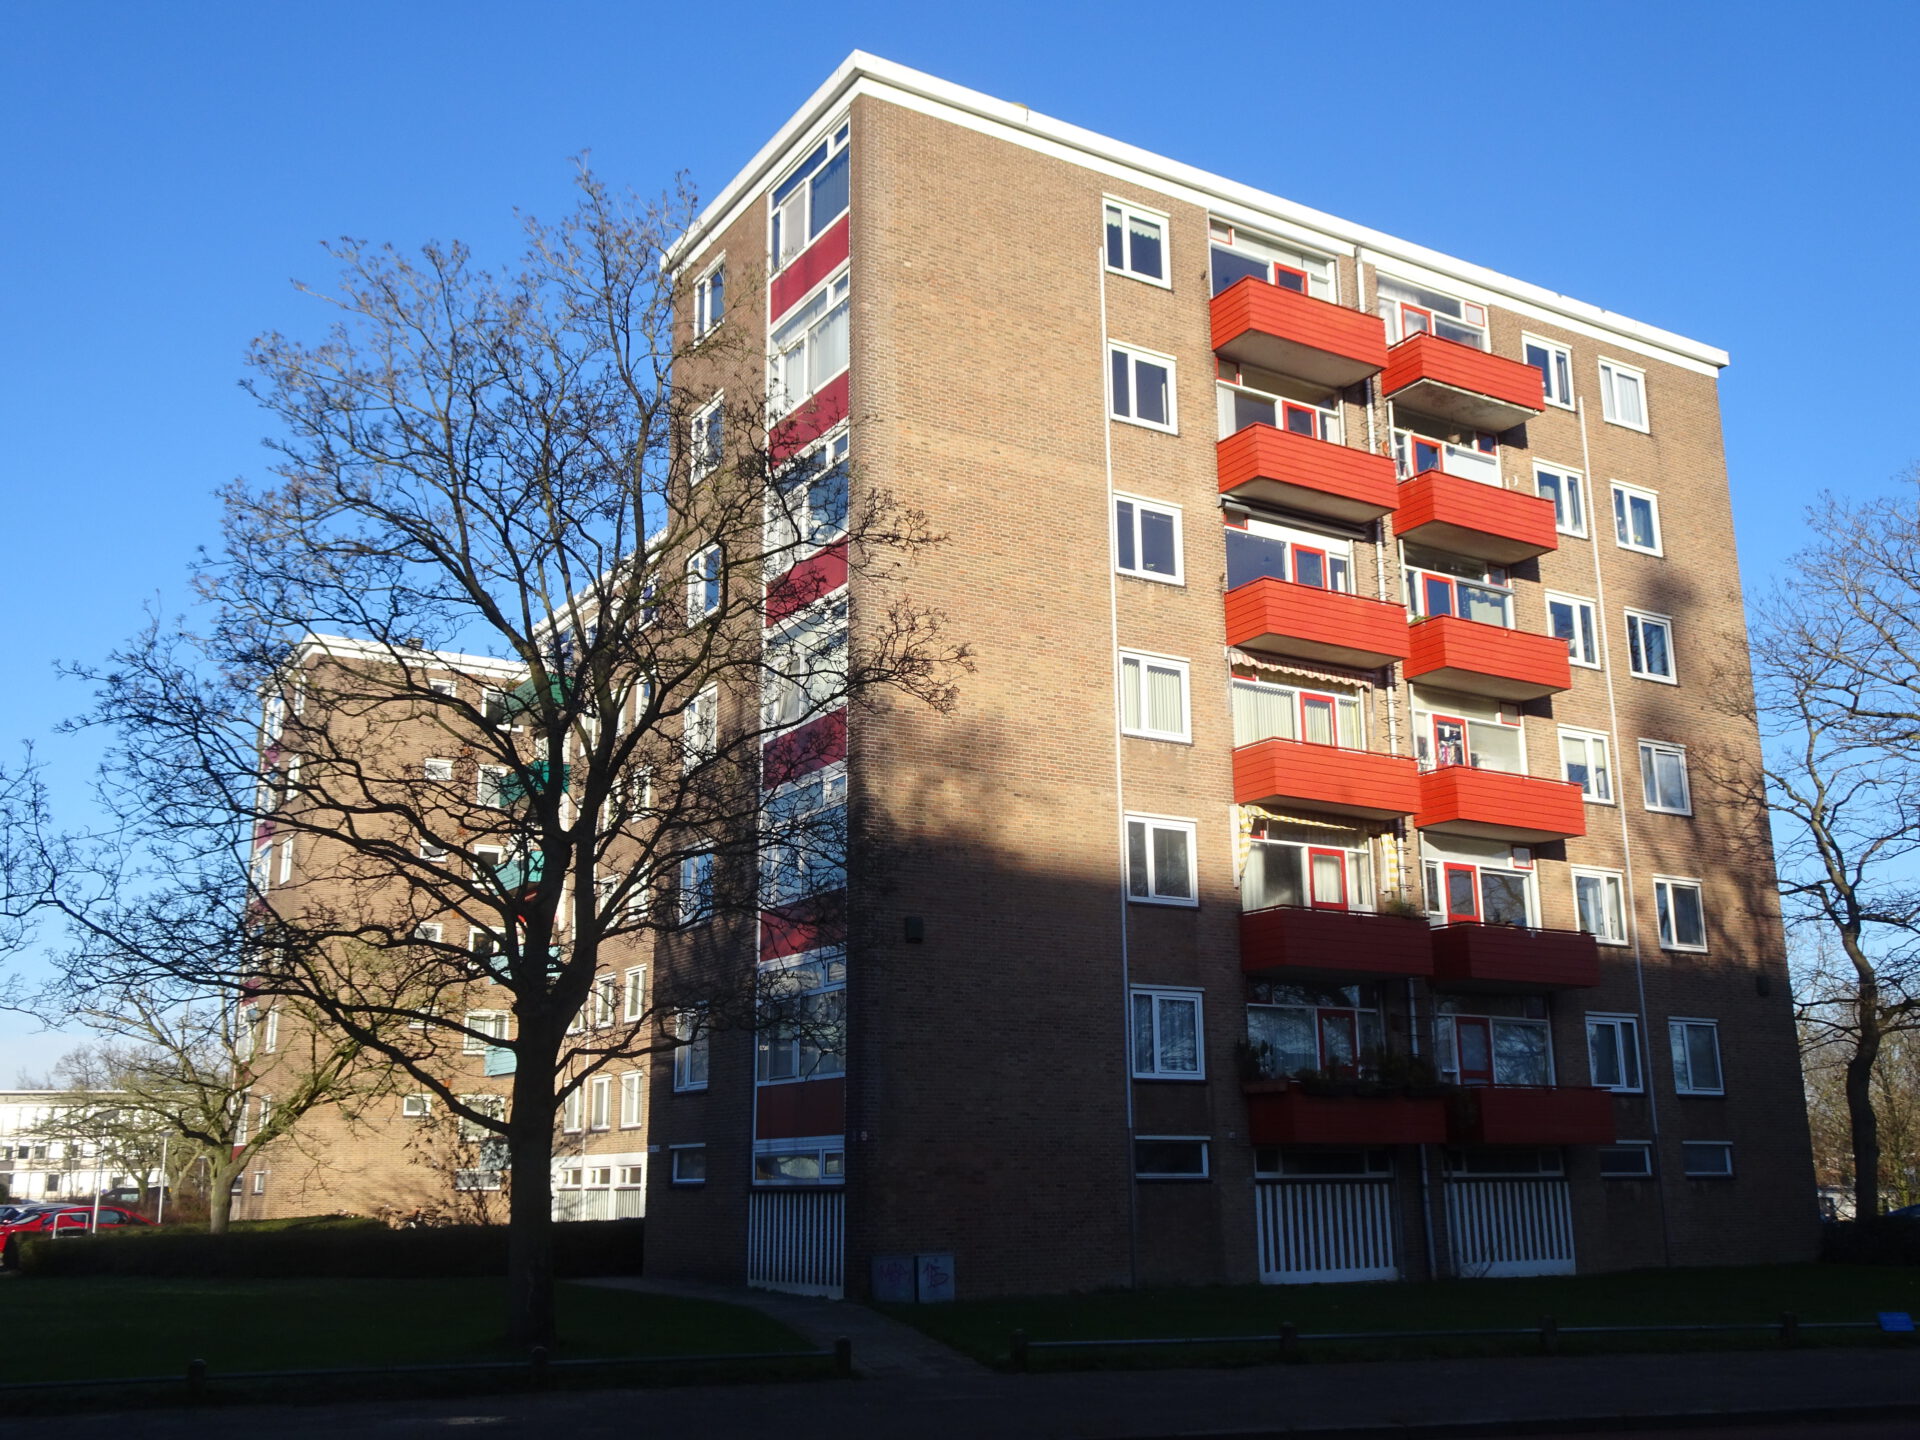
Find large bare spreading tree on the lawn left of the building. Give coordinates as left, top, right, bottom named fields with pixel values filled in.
left=54, top=175, right=966, bottom=1342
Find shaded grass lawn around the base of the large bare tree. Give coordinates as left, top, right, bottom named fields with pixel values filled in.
left=0, top=1277, right=812, bottom=1384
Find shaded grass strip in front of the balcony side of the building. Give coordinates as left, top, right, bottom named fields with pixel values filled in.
left=883, top=1265, right=1920, bottom=1369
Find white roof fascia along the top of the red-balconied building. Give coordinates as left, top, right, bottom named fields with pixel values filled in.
left=668, top=50, right=1728, bottom=374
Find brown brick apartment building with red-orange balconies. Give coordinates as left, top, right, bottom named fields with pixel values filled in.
left=645, top=54, right=1814, bottom=1298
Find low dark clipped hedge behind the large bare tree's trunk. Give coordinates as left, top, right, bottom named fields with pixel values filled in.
left=19, top=1219, right=645, bottom=1279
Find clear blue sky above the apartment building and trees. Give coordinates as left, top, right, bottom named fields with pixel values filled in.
left=0, top=0, right=1920, bottom=1085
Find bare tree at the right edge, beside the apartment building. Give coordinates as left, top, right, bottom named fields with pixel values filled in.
left=1730, top=478, right=1920, bottom=1219
